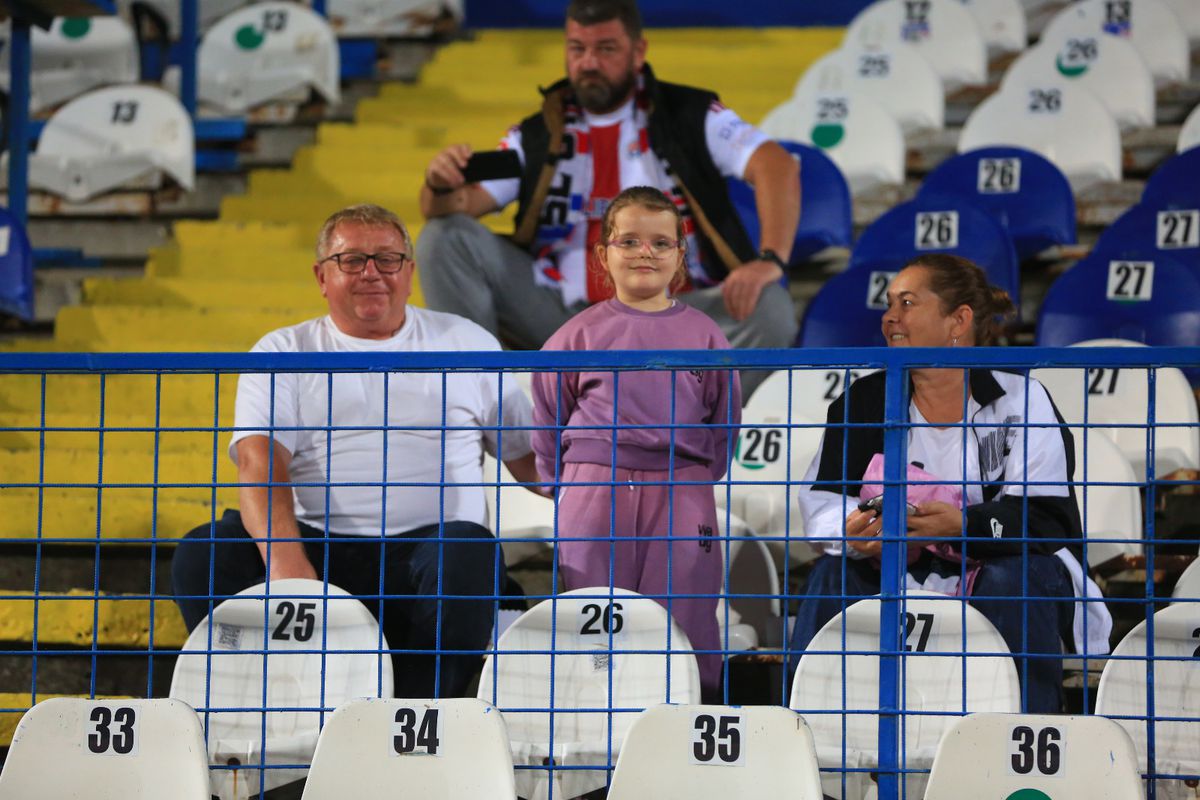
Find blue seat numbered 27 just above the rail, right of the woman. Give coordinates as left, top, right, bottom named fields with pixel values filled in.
left=1037, top=248, right=1200, bottom=385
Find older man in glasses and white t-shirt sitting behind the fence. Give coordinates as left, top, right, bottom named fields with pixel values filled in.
left=172, top=205, right=538, bottom=697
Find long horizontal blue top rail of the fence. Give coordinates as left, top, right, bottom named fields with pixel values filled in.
left=0, top=347, right=1200, bottom=374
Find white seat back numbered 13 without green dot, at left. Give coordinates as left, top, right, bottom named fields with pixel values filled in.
left=31, top=85, right=196, bottom=193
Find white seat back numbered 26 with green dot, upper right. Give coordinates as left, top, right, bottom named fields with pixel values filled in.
left=1001, top=34, right=1154, bottom=130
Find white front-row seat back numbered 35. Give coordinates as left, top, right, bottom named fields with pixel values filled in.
left=608, top=705, right=821, bottom=800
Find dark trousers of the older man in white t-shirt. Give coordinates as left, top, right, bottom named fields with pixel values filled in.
left=170, top=511, right=505, bottom=698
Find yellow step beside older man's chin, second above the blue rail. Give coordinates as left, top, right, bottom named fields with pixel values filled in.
left=83, top=275, right=328, bottom=317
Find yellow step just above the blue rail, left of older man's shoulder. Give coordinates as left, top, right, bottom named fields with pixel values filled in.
left=54, top=306, right=319, bottom=351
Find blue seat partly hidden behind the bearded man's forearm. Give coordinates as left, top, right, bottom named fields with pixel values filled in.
left=728, top=142, right=853, bottom=264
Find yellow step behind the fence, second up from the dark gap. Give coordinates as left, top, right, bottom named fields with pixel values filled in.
left=0, top=448, right=238, bottom=487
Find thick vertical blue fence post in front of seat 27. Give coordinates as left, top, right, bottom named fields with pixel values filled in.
left=878, top=353, right=908, bottom=800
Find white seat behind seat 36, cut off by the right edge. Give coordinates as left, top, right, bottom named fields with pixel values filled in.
left=1096, top=603, right=1200, bottom=800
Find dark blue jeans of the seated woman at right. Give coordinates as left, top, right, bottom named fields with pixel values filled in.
left=788, top=553, right=1074, bottom=714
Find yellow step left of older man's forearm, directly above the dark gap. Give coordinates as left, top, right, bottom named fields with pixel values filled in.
left=0, top=488, right=238, bottom=543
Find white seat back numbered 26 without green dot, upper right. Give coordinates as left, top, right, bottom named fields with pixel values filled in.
left=959, top=84, right=1122, bottom=192
